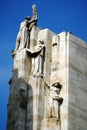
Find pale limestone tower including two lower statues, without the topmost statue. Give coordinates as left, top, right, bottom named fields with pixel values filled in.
left=7, top=26, right=87, bottom=130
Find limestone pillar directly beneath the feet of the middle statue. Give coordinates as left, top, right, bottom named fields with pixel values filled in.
left=26, top=76, right=44, bottom=130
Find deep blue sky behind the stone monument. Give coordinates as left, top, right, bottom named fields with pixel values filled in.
left=0, top=0, right=87, bottom=130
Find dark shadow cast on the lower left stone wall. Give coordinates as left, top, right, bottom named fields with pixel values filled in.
left=7, top=69, right=33, bottom=130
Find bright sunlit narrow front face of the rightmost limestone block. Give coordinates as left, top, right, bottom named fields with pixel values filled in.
left=58, top=32, right=68, bottom=130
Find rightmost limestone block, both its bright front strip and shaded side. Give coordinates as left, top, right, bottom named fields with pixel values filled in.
left=58, top=32, right=87, bottom=130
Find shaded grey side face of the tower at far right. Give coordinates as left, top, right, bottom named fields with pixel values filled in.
left=68, top=34, right=87, bottom=130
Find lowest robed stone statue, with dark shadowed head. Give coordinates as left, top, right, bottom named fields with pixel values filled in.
left=50, top=82, right=63, bottom=121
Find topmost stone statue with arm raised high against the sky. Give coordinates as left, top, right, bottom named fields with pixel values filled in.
left=15, top=5, right=37, bottom=50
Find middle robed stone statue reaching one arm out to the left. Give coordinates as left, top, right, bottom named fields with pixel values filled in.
left=28, top=41, right=45, bottom=76
